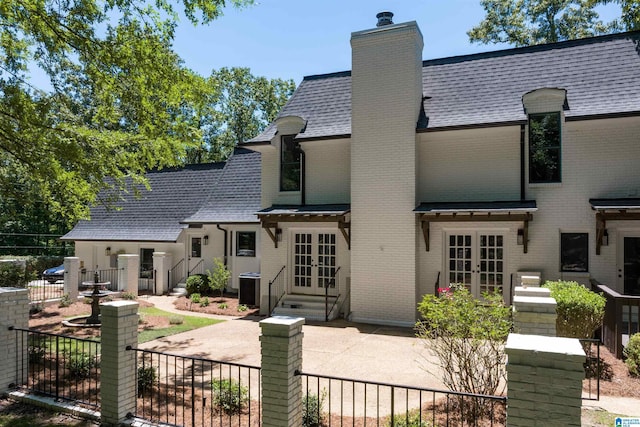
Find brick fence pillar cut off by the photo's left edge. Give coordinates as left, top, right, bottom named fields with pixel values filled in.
left=0, top=288, right=29, bottom=395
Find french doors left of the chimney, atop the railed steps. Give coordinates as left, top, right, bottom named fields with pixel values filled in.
left=291, top=232, right=336, bottom=295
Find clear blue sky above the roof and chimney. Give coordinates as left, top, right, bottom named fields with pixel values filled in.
left=174, top=0, right=619, bottom=85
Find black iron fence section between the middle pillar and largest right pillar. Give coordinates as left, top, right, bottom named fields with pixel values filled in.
left=297, top=372, right=507, bottom=426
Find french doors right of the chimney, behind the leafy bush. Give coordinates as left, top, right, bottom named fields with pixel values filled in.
left=445, top=231, right=505, bottom=298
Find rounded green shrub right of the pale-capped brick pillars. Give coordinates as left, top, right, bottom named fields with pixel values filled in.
left=543, top=281, right=606, bottom=338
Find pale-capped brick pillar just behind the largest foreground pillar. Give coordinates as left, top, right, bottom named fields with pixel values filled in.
left=513, top=286, right=557, bottom=337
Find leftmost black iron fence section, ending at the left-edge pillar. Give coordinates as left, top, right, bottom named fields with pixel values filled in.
left=10, top=327, right=100, bottom=408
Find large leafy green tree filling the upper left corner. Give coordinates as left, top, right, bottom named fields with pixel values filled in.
left=0, top=0, right=252, bottom=223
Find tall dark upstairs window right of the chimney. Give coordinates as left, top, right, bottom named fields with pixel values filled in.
left=529, top=113, right=561, bottom=183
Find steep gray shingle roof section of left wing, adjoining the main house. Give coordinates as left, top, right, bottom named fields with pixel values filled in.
left=183, top=148, right=261, bottom=224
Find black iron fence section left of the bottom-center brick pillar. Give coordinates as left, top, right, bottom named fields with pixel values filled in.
left=127, top=347, right=261, bottom=427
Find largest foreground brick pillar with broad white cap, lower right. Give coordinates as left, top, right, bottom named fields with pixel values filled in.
left=505, top=334, right=585, bottom=427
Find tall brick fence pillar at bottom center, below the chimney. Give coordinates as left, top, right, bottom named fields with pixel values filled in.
left=260, top=317, right=304, bottom=427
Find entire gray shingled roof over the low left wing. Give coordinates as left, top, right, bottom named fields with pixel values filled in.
left=62, top=149, right=260, bottom=242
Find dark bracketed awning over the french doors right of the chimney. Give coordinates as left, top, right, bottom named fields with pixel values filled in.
left=414, top=200, right=538, bottom=253
